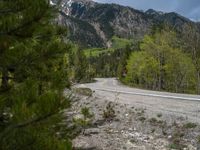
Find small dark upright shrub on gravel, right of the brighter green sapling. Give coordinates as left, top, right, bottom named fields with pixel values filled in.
left=103, top=102, right=116, bottom=120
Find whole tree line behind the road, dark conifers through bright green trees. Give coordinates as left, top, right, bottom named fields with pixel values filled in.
left=88, top=24, right=200, bottom=94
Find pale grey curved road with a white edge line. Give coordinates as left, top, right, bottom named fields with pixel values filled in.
left=79, top=78, right=200, bottom=123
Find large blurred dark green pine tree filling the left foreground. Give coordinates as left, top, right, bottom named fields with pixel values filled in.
left=0, top=0, right=71, bottom=150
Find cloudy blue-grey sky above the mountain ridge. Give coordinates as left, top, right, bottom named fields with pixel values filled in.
left=94, top=0, right=200, bottom=21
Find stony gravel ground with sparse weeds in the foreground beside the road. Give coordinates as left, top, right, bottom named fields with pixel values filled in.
left=66, top=89, right=200, bottom=150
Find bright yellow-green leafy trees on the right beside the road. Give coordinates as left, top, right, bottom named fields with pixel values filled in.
left=119, top=28, right=200, bottom=94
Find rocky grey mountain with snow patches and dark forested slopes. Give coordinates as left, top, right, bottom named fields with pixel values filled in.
left=54, top=0, right=200, bottom=47
